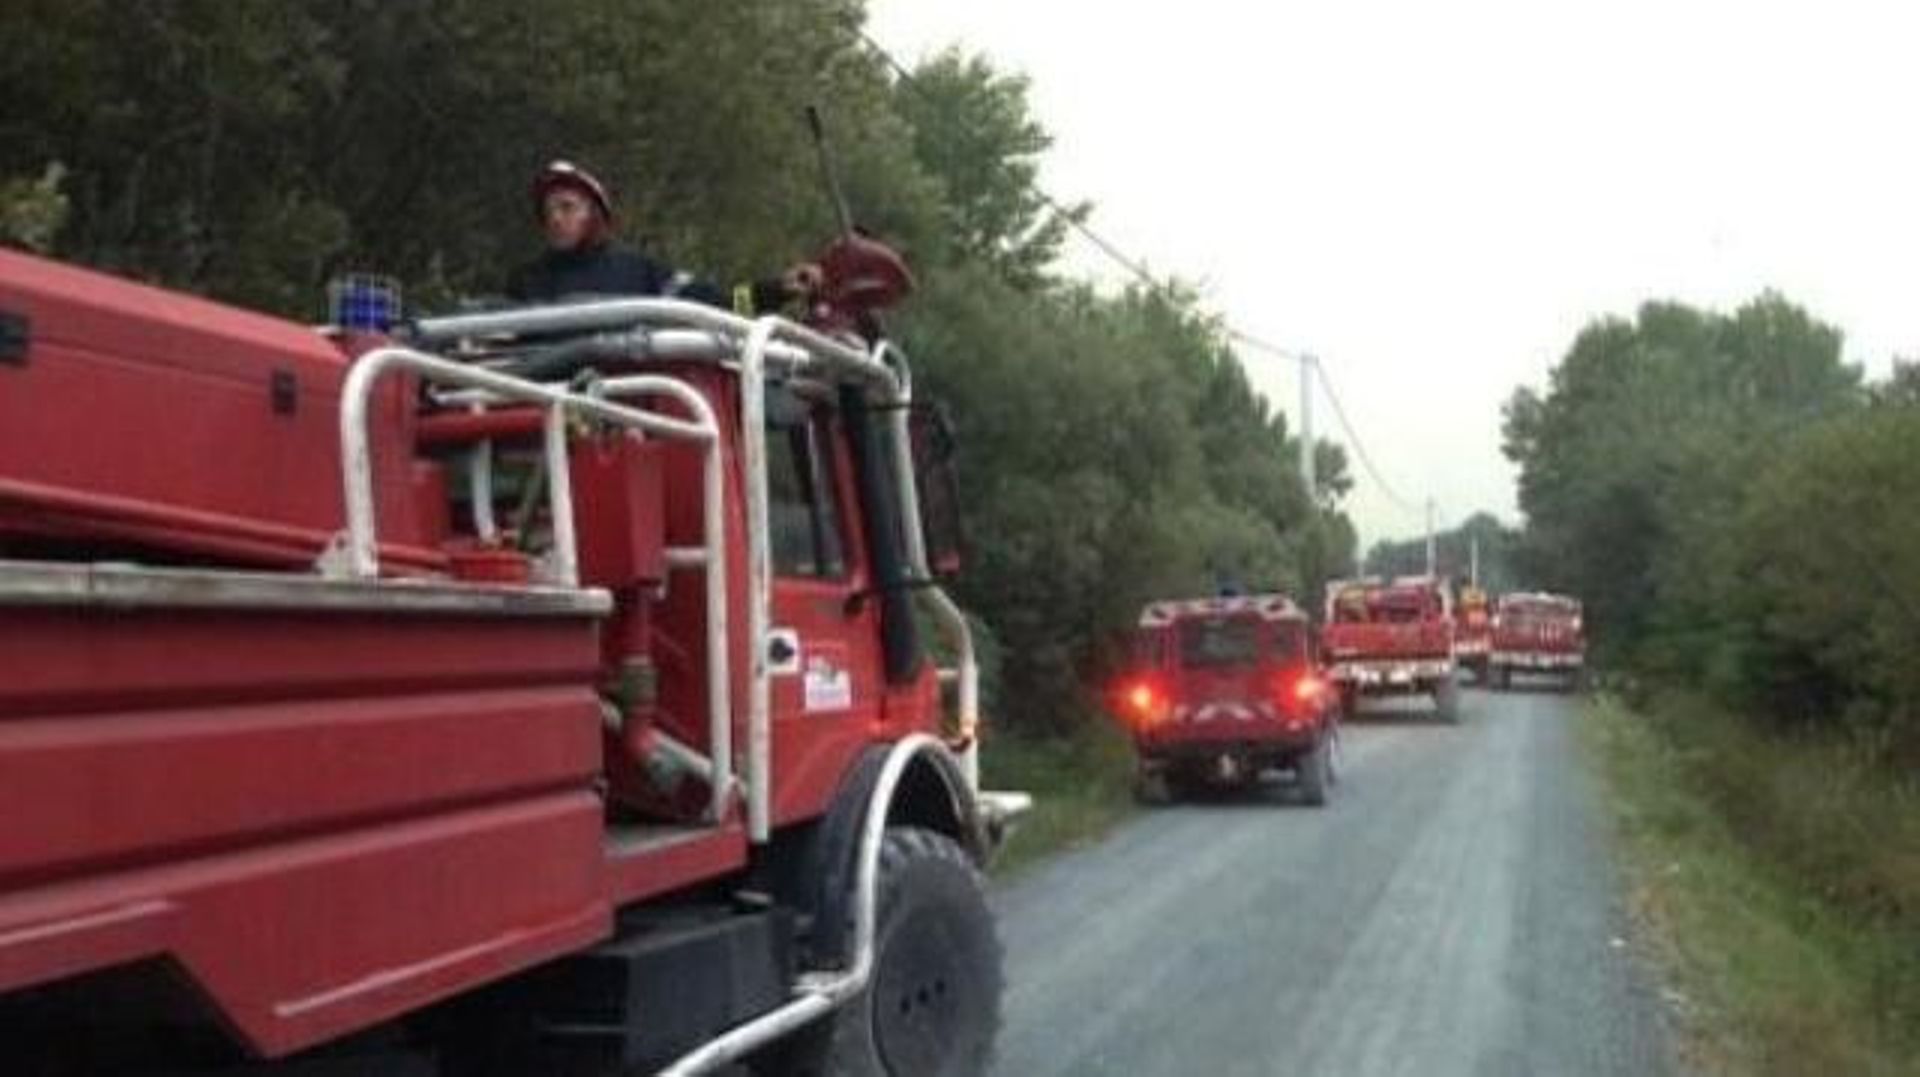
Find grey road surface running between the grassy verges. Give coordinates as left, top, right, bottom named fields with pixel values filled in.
left=995, top=691, right=1674, bottom=1077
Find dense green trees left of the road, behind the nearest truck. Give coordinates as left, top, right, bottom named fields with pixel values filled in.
left=0, top=0, right=1354, bottom=726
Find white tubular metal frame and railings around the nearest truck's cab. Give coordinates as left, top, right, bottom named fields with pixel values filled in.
left=360, top=299, right=1029, bottom=1073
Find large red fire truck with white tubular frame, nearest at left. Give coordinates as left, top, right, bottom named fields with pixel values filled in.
left=0, top=236, right=1023, bottom=1075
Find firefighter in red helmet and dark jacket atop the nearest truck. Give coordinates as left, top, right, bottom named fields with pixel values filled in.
left=507, top=161, right=820, bottom=315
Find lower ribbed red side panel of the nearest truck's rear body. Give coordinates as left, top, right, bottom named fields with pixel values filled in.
left=0, top=579, right=629, bottom=1054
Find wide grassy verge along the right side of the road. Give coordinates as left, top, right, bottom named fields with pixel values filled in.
left=1580, top=697, right=1920, bottom=1077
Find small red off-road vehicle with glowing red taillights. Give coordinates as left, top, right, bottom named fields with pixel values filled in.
left=1110, top=595, right=1340, bottom=806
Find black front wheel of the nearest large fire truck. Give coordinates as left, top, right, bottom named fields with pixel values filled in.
left=798, top=827, right=1002, bottom=1077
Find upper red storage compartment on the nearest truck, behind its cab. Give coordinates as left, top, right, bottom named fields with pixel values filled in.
left=0, top=250, right=445, bottom=568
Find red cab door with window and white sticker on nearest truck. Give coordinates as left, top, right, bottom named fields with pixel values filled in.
left=766, top=386, right=887, bottom=826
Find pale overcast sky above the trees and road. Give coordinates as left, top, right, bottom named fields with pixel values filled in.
left=870, top=0, right=1920, bottom=541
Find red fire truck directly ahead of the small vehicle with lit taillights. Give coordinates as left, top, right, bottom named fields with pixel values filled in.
left=1321, top=576, right=1459, bottom=722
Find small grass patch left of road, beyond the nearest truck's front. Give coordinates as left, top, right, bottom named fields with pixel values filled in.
left=981, top=720, right=1135, bottom=879
